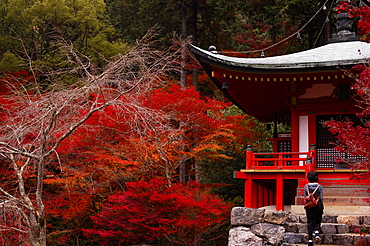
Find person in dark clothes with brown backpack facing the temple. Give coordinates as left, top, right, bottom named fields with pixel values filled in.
left=304, top=171, right=324, bottom=246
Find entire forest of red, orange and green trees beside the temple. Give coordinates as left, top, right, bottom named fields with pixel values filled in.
left=0, top=0, right=368, bottom=245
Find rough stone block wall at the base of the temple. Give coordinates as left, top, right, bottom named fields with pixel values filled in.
left=228, top=207, right=370, bottom=246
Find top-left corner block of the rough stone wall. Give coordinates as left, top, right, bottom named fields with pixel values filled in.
left=230, top=207, right=265, bottom=226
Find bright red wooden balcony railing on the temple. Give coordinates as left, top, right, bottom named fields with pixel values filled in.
left=246, top=145, right=316, bottom=171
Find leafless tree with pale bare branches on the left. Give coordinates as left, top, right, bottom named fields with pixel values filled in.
left=0, top=32, right=184, bottom=246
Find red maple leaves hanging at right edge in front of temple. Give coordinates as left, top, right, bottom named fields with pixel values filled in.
left=325, top=1, right=370, bottom=179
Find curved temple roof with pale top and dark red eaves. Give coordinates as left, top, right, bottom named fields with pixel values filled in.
left=190, top=41, right=370, bottom=121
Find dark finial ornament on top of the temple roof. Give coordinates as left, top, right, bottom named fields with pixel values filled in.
left=329, top=0, right=360, bottom=43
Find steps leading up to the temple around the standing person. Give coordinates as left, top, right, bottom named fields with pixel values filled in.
left=286, top=179, right=370, bottom=245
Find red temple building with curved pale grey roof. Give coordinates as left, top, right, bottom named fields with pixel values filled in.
left=190, top=0, right=370, bottom=213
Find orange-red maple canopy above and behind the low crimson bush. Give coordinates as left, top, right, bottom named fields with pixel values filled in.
left=36, top=85, right=254, bottom=242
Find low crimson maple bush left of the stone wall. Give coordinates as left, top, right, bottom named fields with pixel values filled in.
left=84, top=179, right=231, bottom=245
